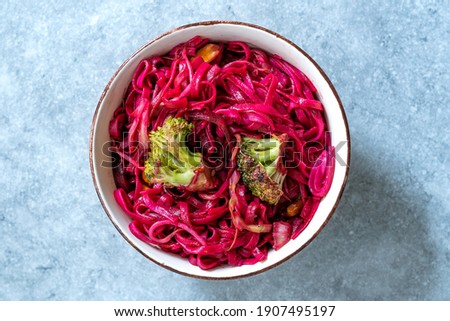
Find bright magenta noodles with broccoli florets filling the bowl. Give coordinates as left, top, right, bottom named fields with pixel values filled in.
left=109, top=36, right=334, bottom=270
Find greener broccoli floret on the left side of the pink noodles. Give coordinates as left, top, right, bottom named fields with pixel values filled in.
left=144, top=117, right=212, bottom=191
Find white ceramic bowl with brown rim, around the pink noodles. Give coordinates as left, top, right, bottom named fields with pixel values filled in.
left=90, top=21, right=350, bottom=279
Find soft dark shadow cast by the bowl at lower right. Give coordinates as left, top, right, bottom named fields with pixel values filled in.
left=192, top=148, right=436, bottom=300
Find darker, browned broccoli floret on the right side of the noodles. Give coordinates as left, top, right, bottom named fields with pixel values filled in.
left=238, top=135, right=286, bottom=205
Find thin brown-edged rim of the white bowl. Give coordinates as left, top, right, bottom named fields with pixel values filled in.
left=89, top=20, right=351, bottom=280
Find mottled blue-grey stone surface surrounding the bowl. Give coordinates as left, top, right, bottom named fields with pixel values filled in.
left=0, top=0, right=450, bottom=300
